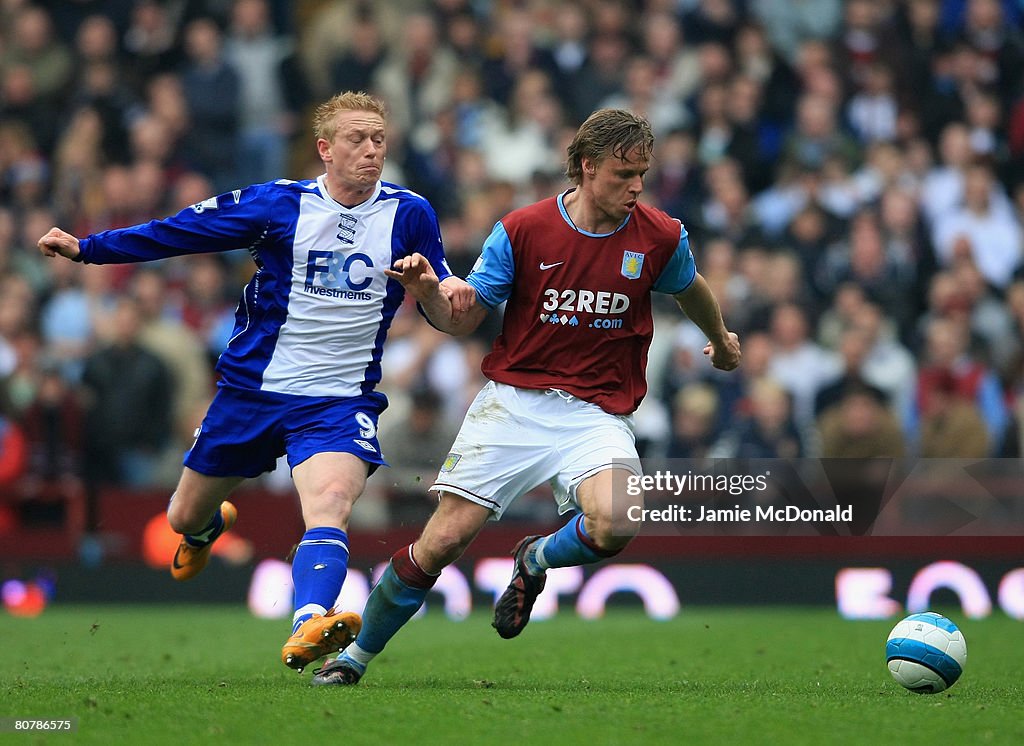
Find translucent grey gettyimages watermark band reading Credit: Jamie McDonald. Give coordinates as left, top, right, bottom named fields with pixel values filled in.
left=613, top=458, right=1024, bottom=536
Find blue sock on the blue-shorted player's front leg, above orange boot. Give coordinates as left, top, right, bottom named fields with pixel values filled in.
left=292, top=526, right=348, bottom=632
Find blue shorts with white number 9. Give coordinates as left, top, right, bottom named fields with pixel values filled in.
left=184, top=386, right=387, bottom=477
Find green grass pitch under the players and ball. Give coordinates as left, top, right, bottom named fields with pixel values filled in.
left=0, top=606, right=1024, bottom=746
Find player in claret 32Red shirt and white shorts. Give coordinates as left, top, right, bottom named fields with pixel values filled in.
left=312, top=109, right=739, bottom=685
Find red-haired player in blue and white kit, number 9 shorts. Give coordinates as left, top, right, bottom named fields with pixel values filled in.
left=39, top=91, right=474, bottom=670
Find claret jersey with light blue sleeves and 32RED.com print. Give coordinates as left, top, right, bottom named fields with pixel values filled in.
left=467, top=193, right=696, bottom=414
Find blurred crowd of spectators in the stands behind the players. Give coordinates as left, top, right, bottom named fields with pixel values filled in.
left=0, top=0, right=1024, bottom=528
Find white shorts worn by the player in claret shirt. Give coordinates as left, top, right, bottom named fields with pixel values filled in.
left=430, top=381, right=641, bottom=520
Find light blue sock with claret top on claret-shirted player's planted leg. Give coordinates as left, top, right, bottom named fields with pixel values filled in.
left=349, top=545, right=438, bottom=654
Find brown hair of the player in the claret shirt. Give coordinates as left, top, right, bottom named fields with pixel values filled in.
left=565, top=108, right=654, bottom=184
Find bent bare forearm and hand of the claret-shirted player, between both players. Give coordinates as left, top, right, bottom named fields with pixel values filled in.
left=384, top=254, right=487, bottom=337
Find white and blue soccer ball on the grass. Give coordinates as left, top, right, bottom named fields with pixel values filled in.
left=886, top=611, right=967, bottom=694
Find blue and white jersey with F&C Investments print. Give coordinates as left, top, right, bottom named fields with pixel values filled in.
left=80, top=176, right=452, bottom=396
